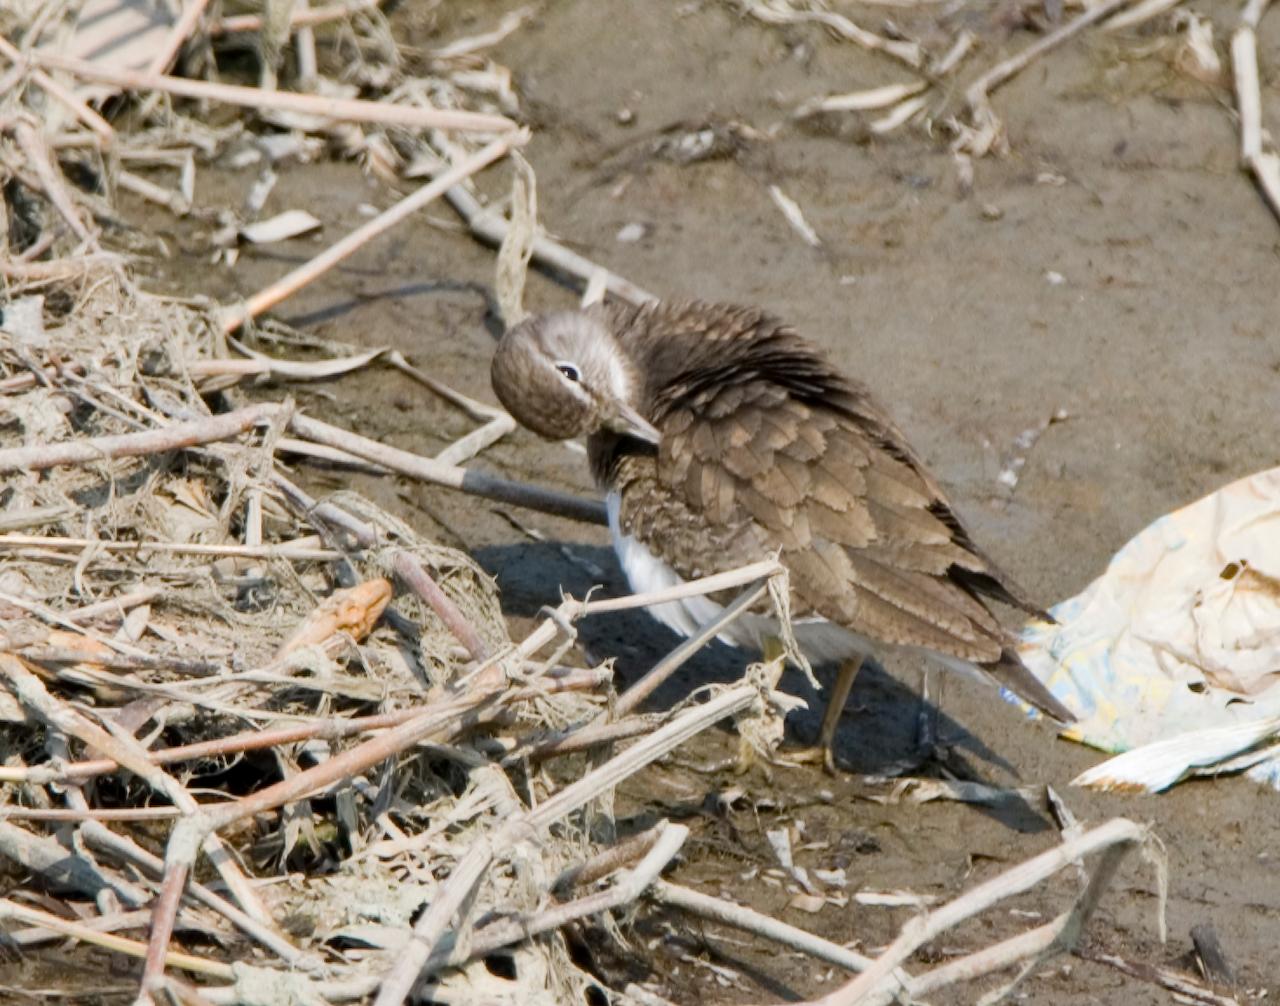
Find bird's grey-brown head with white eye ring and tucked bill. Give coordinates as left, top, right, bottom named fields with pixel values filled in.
left=489, top=311, right=658, bottom=444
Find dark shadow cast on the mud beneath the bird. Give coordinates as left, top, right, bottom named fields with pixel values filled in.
left=474, top=541, right=1048, bottom=832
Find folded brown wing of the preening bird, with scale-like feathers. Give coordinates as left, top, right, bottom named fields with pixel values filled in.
left=657, top=368, right=1005, bottom=663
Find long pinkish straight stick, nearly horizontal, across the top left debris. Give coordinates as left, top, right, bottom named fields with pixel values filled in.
left=29, top=50, right=518, bottom=133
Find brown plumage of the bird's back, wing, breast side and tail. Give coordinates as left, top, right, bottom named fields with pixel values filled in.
left=596, top=305, right=1069, bottom=718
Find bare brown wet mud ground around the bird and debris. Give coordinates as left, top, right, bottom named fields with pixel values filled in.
left=24, top=0, right=1280, bottom=1006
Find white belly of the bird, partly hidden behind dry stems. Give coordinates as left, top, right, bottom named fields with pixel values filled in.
left=604, top=493, right=876, bottom=663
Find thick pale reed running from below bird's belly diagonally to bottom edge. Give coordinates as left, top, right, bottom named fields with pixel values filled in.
left=375, top=685, right=759, bottom=1006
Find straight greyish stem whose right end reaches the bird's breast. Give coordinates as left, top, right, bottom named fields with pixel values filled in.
left=290, top=413, right=607, bottom=525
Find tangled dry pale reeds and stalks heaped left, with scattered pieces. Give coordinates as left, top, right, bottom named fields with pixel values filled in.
left=0, top=0, right=1187, bottom=1006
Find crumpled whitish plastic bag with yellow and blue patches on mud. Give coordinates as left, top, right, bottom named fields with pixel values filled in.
left=1019, top=468, right=1280, bottom=792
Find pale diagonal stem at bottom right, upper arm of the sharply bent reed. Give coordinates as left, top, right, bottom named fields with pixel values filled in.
left=817, top=818, right=1148, bottom=1006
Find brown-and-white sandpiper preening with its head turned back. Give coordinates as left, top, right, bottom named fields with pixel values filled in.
left=492, top=302, right=1074, bottom=769
